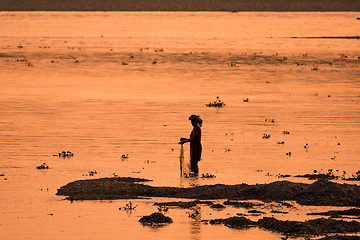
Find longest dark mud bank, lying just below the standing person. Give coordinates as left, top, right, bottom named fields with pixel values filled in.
left=56, top=177, right=360, bottom=207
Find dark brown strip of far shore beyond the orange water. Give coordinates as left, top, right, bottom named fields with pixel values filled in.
left=0, top=0, right=360, bottom=12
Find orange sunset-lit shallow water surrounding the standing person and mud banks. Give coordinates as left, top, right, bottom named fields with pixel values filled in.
left=0, top=12, right=360, bottom=239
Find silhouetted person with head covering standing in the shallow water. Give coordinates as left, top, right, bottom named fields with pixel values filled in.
left=179, top=115, right=202, bottom=175
